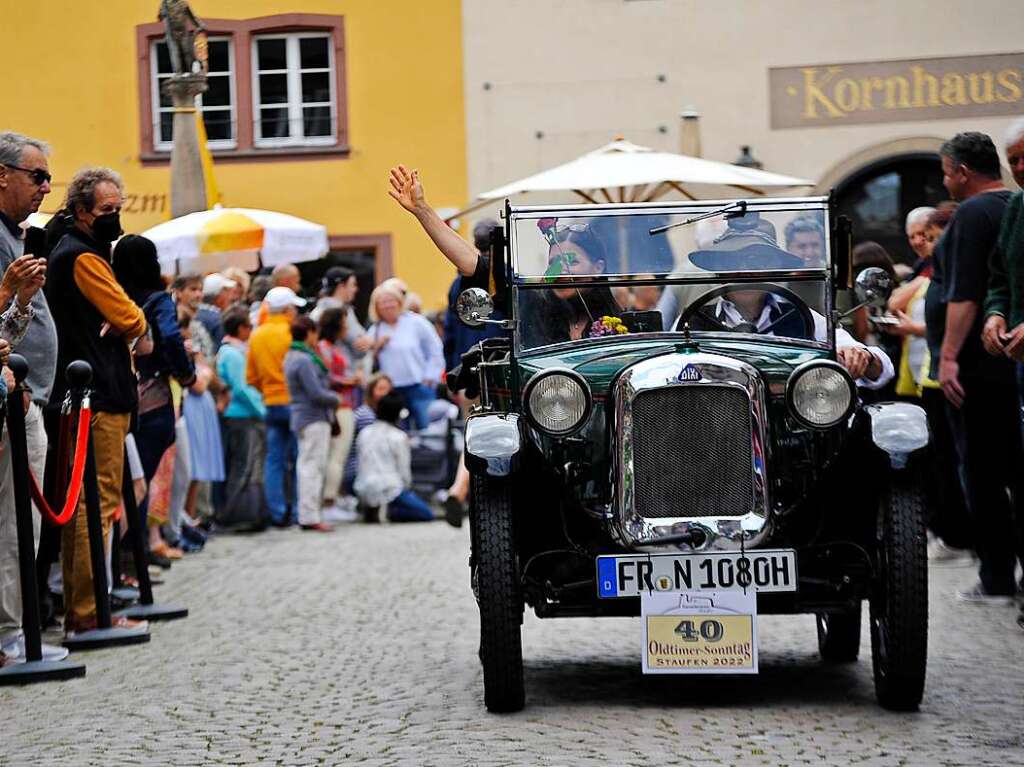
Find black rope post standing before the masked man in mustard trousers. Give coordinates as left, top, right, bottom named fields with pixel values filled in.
left=63, top=360, right=150, bottom=649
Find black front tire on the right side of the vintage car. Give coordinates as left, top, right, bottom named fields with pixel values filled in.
left=870, top=478, right=928, bottom=711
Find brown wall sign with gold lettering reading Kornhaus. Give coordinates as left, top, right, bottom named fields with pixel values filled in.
left=768, top=53, right=1024, bottom=129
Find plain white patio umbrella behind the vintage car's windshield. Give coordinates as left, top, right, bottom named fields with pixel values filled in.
left=450, top=138, right=814, bottom=218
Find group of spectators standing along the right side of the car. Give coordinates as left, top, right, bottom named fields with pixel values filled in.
left=854, top=125, right=1024, bottom=628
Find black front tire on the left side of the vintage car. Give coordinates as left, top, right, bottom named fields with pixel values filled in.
left=470, top=475, right=524, bottom=713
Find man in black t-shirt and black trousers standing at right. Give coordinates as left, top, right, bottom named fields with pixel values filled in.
left=925, top=133, right=1024, bottom=601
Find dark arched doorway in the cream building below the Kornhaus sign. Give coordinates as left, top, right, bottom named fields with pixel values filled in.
left=835, top=152, right=949, bottom=263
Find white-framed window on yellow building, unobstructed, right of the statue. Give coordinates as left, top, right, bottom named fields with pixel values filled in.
left=252, top=34, right=337, bottom=146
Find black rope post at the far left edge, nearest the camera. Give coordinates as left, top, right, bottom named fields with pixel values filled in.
left=0, top=354, right=85, bottom=685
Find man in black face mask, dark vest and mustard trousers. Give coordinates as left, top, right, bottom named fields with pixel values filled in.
left=46, top=168, right=147, bottom=635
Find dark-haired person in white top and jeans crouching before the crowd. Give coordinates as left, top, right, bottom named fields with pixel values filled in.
left=355, top=391, right=434, bottom=522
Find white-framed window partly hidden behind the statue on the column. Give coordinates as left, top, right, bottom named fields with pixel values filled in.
left=150, top=37, right=238, bottom=152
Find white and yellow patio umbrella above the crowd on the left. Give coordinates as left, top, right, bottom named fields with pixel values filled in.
left=142, top=206, right=329, bottom=274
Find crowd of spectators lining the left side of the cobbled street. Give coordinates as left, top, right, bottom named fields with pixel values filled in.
left=0, top=132, right=461, bottom=666
